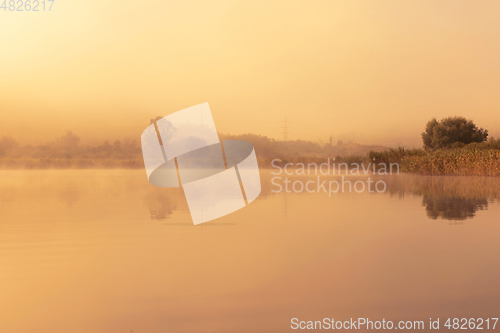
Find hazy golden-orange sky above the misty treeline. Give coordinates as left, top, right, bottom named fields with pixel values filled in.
left=0, top=0, right=500, bottom=145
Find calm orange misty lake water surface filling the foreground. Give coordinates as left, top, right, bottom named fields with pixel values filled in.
left=0, top=170, right=500, bottom=333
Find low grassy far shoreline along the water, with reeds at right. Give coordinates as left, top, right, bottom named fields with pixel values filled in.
left=0, top=147, right=500, bottom=177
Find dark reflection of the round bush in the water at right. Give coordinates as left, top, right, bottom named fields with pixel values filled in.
left=422, top=195, right=488, bottom=220
